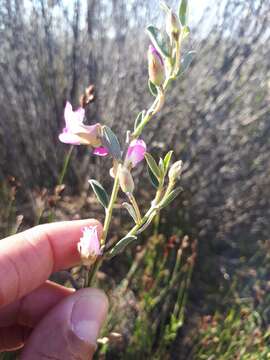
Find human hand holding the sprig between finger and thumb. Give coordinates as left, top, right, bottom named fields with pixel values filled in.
left=0, top=220, right=108, bottom=360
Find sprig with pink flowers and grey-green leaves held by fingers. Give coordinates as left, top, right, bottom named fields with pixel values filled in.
left=59, top=0, right=194, bottom=286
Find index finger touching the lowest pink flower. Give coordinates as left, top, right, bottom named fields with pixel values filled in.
left=0, top=219, right=102, bottom=307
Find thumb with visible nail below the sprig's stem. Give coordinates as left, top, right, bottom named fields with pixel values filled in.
left=21, top=289, right=108, bottom=360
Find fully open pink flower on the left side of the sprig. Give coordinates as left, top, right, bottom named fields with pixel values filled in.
left=59, top=102, right=108, bottom=156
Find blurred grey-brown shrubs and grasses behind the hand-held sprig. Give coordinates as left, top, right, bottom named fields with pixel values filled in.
left=0, top=0, right=270, bottom=360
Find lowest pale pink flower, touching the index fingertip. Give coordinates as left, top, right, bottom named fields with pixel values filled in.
left=77, top=226, right=102, bottom=266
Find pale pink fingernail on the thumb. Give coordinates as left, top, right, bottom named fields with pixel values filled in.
left=71, top=289, right=108, bottom=344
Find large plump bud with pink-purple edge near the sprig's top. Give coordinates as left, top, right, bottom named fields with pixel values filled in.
left=148, top=45, right=165, bottom=86
